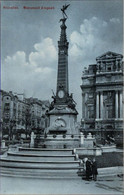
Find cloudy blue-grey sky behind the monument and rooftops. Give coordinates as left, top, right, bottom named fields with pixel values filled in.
left=1, top=0, right=123, bottom=121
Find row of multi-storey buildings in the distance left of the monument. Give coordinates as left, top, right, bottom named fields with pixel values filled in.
left=0, top=90, right=50, bottom=139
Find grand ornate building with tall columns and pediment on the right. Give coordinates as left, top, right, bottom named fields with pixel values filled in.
left=81, top=51, right=123, bottom=139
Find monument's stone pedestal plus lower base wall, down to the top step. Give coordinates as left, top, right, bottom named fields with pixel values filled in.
left=44, top=104, right=80, bottom=149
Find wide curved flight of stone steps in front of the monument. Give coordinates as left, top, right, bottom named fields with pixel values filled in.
left=0, top=148, right=80, bottom=178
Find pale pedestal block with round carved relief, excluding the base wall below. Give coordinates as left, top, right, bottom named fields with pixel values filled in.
left=46, top=105, right=79, bottom=135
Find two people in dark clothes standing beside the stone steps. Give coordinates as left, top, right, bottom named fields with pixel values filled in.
left=84, top=158, right=98, bottom=181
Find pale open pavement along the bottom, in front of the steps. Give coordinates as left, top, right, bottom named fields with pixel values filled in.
left=0, top=176, right=124, bottom=195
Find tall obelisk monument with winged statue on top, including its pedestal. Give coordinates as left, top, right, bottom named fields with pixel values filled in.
left=45, top=5, right=79, bottom=146
